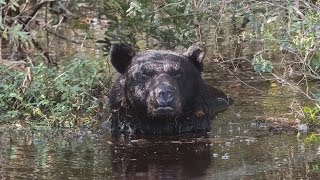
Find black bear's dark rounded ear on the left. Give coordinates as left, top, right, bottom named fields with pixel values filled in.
left=110, top=43, right=135, bottom=74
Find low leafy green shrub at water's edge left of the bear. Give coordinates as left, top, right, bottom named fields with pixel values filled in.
left=0, top=58, right=110, bottom=126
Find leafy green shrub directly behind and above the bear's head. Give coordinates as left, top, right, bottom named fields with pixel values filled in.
left=103, top=0, right=205, bottom=49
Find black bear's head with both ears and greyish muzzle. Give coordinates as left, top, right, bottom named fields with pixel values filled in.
left=111, top=44, right=204, bottom=119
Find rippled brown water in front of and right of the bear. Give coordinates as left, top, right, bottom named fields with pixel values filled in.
left=0, top=63, right=320, bottom=179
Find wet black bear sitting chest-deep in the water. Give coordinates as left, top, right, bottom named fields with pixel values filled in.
left=109, top=43, right=229, bottom=134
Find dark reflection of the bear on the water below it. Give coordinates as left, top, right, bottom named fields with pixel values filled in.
left=111, top=137, right=211, bottom=179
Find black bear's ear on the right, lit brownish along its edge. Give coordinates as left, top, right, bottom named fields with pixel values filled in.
left=183, top=46, right=204, bottom=72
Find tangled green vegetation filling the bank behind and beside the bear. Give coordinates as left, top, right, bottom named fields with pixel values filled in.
left=0, top=0, right=320, bottom=132
